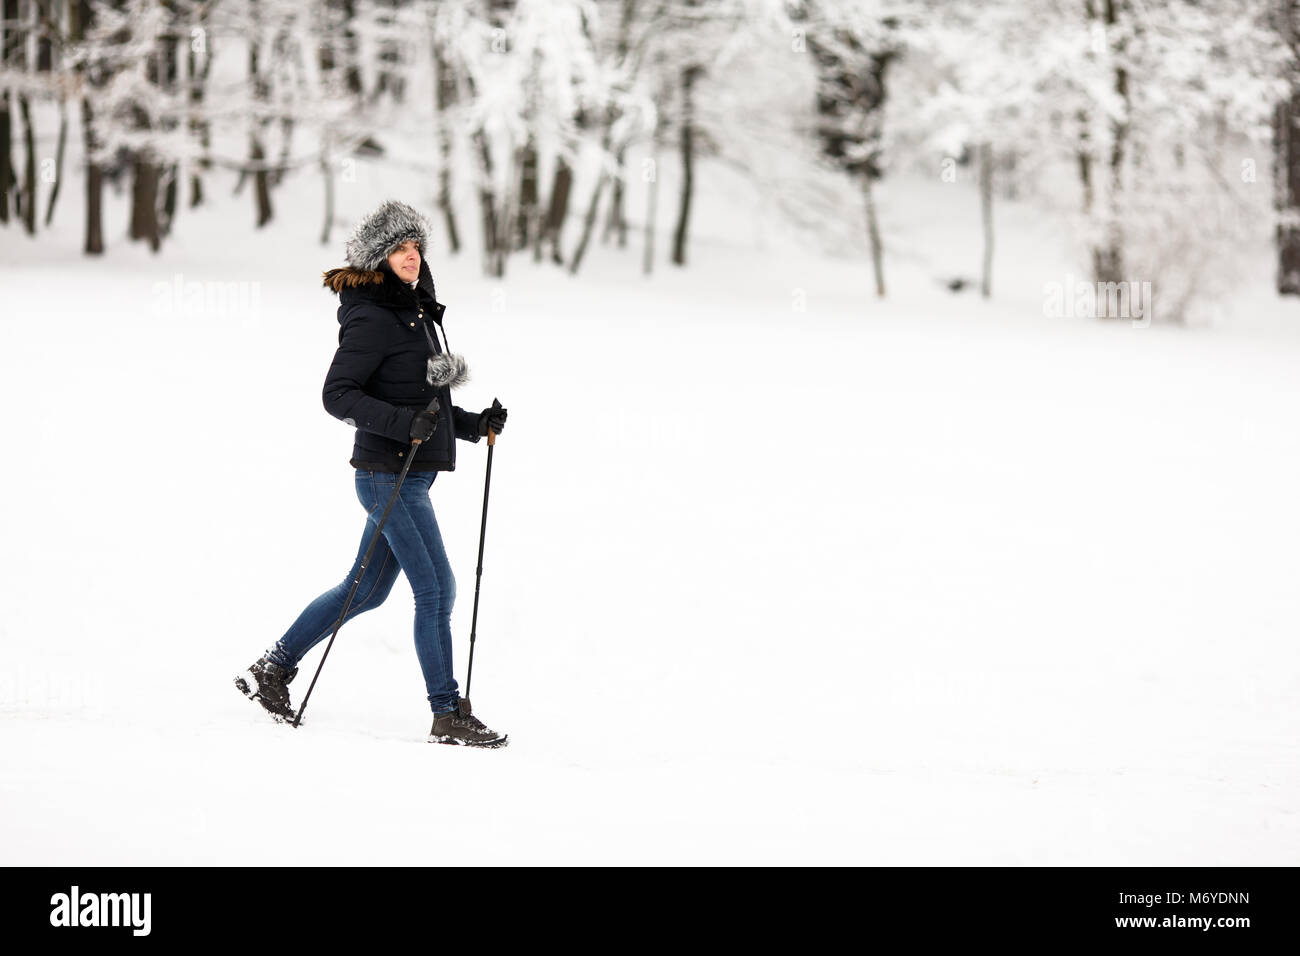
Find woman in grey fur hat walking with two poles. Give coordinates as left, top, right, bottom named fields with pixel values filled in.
left=235, top=202, right=507, bottom=747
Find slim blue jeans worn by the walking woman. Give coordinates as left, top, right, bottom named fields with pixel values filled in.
left=267, top=470, right=460, bottom=714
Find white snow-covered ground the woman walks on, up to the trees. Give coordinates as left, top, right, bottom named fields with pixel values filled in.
left=0, top=164, right=1300, bottom=865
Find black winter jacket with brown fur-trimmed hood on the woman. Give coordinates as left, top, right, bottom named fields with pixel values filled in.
left=321, top=261, right=480, bottom=472
